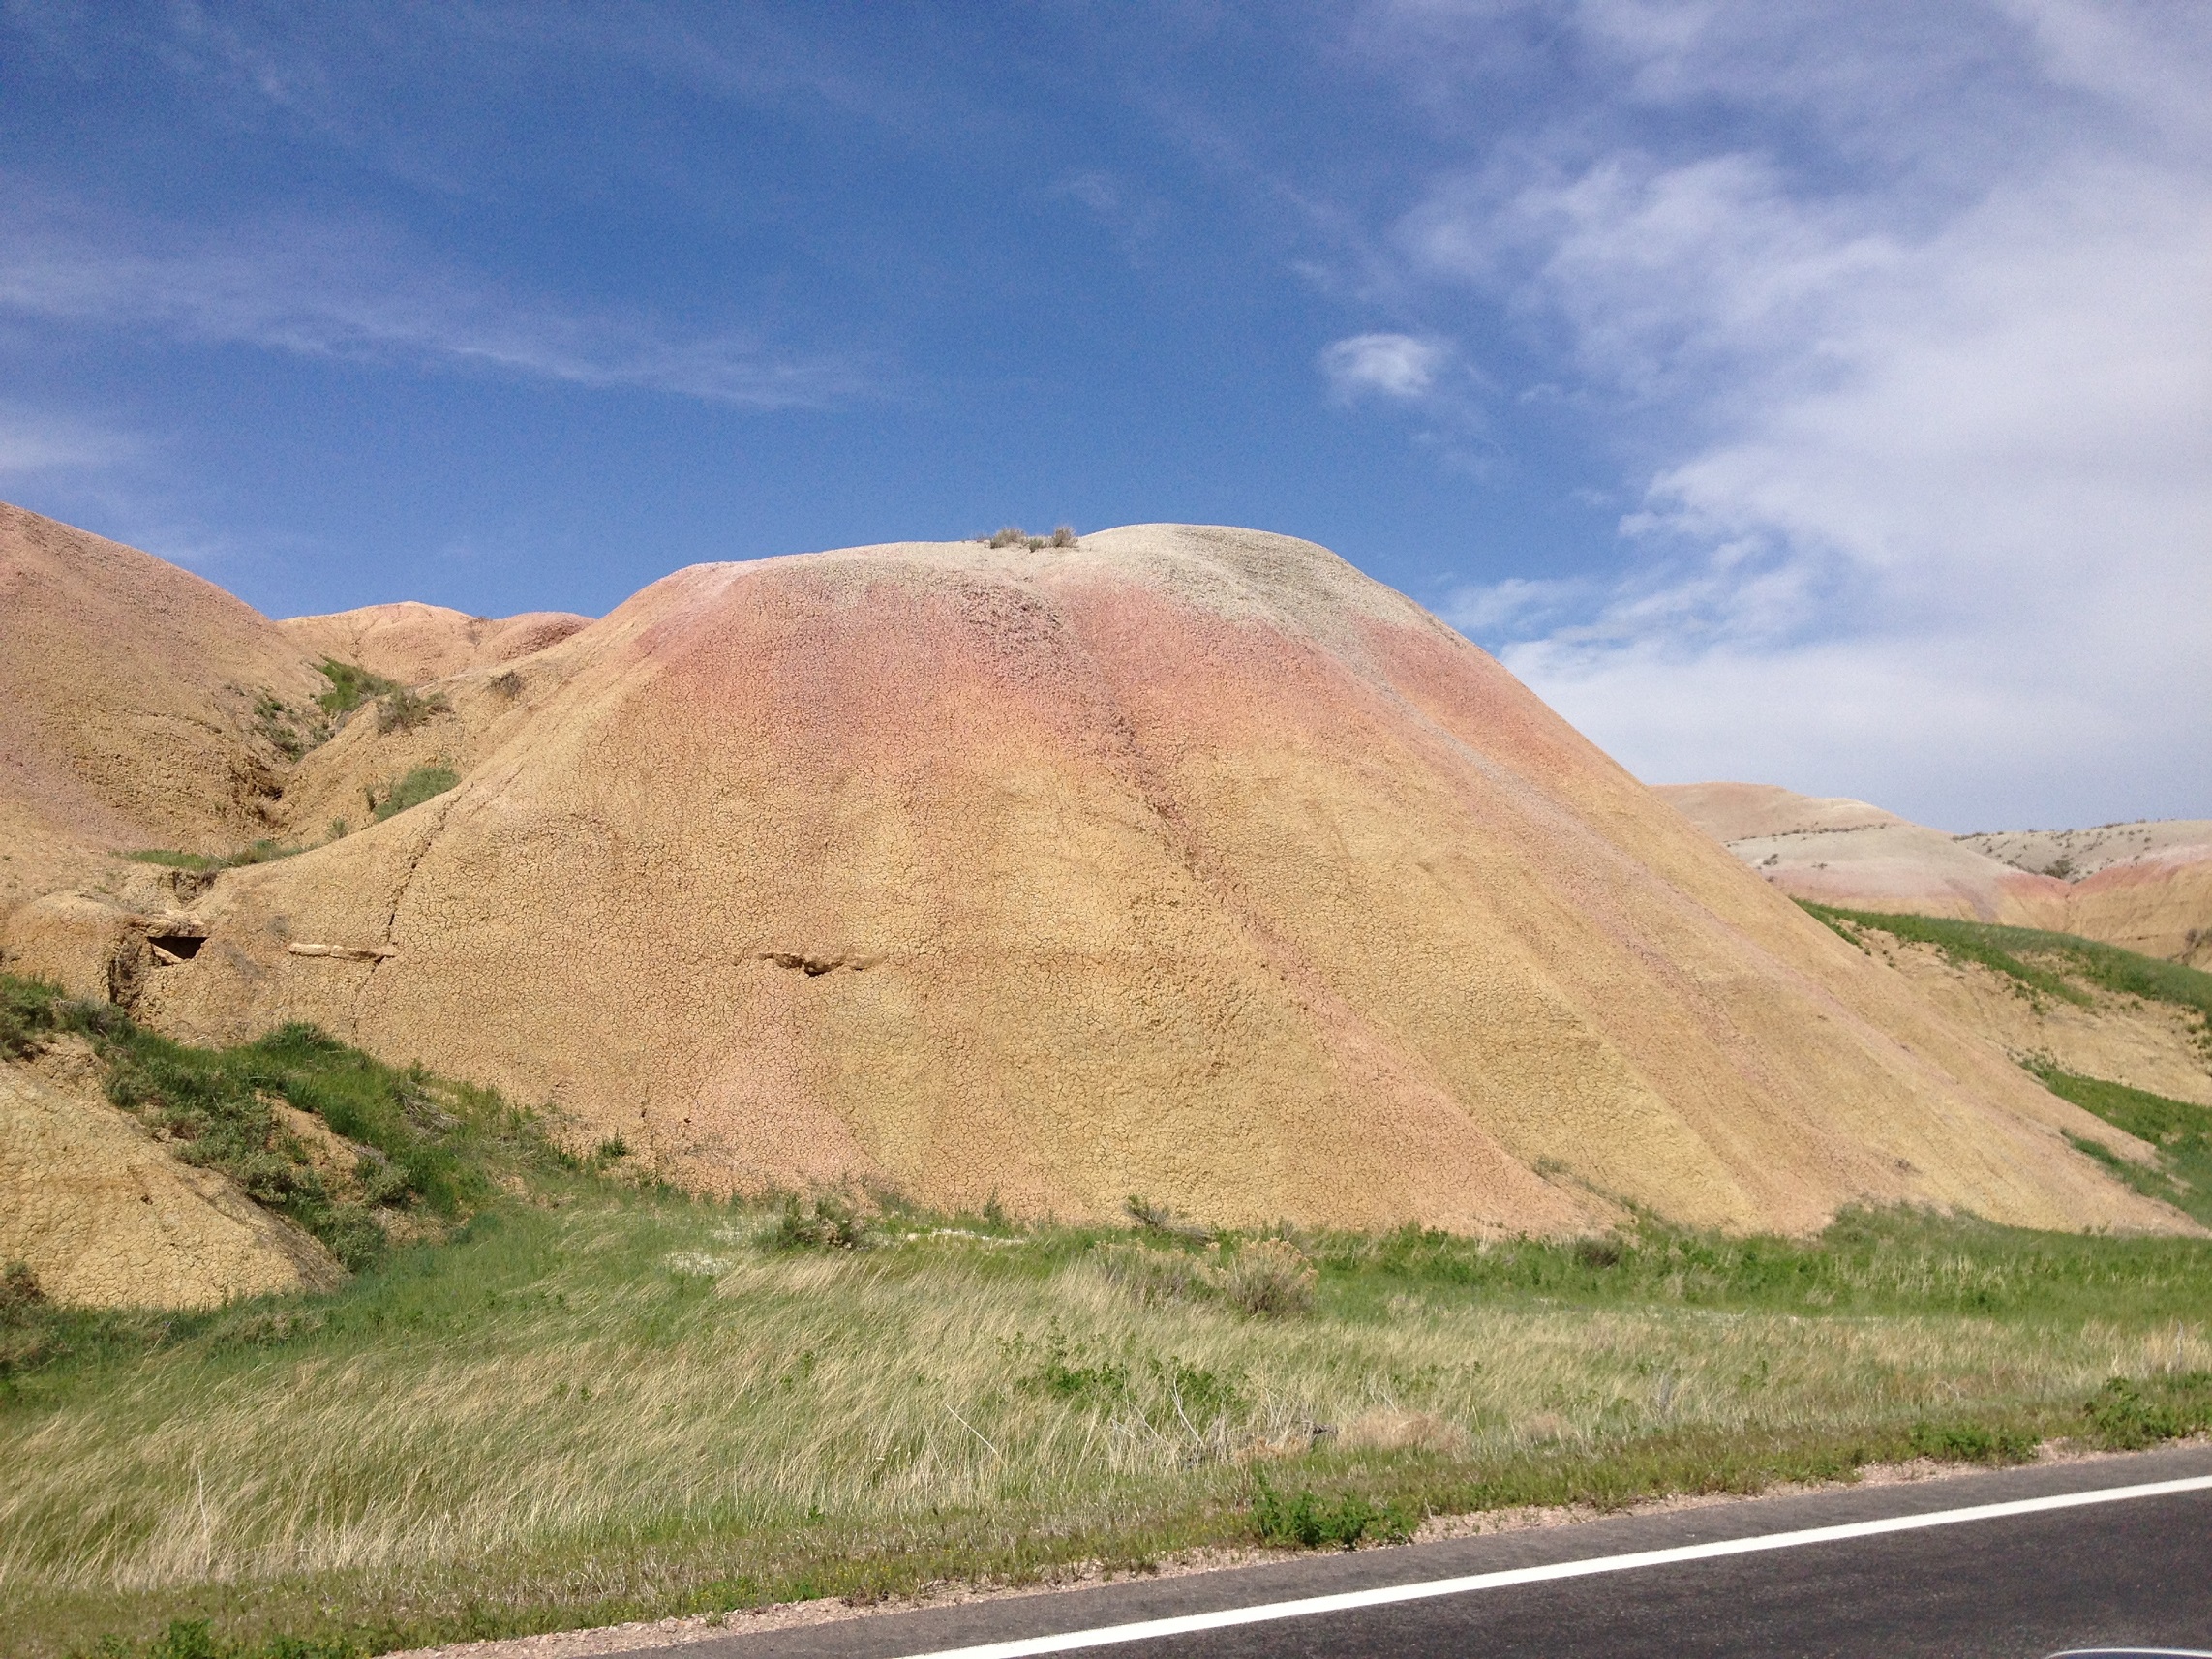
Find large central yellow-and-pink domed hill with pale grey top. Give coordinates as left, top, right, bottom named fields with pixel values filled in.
left=0, top=499, right=2186, bottom=1232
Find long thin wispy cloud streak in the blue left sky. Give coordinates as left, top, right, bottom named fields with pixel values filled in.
left=0, top=203, right=874, bottom=409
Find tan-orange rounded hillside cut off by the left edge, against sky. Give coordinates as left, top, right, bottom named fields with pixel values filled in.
left=0, top=502, right=323, bottom=871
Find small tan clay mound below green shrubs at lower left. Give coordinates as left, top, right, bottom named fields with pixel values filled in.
left=0, top=1051, right=345, bottom=1308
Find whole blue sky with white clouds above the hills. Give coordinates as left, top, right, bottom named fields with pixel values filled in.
left=0, top=0, right=2212, bottom=831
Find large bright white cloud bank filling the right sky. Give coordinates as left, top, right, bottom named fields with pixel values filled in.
left=1371, top=0, right=2212, bottom=828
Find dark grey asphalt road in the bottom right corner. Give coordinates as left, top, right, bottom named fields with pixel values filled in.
left=664, top=1447, right=2212, bottom=1659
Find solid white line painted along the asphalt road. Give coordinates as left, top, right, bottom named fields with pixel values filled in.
left=889, top=1475, right=2212, bottom=1659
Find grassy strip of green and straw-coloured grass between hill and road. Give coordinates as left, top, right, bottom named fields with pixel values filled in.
left=0, top=981, right=2212, bottom=1654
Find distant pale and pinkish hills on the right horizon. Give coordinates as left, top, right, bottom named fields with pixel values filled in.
left=1656, top=783, right=2212, bottom=967
